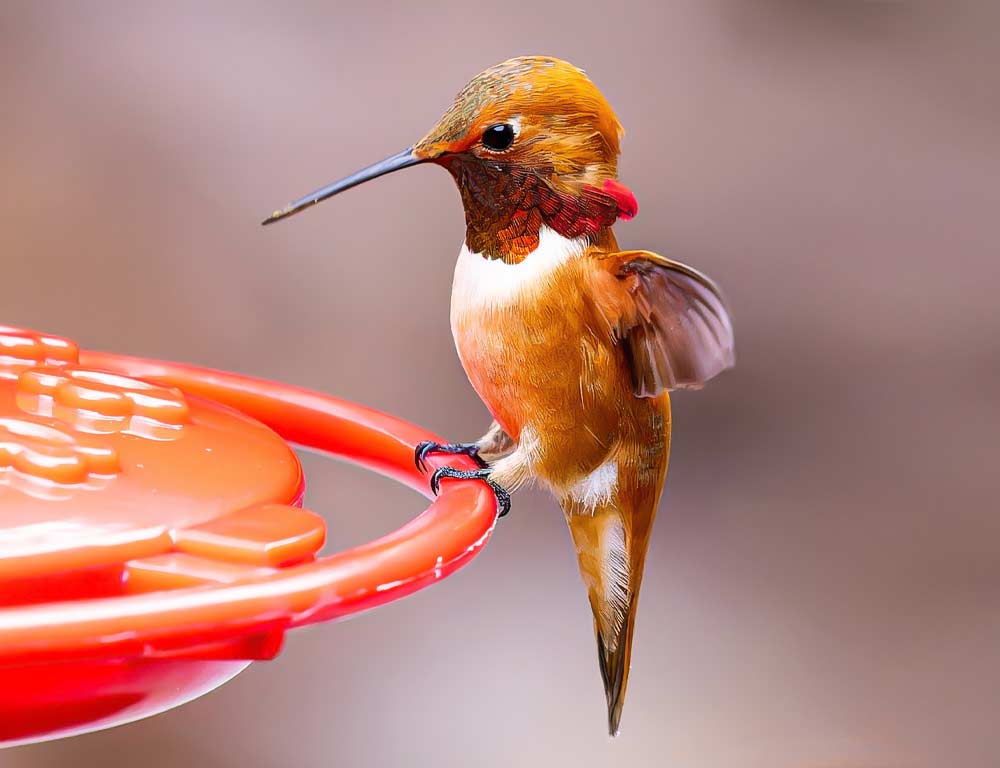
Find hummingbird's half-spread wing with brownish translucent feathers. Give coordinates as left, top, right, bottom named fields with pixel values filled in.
left=615, top=251, right=734, bottom=397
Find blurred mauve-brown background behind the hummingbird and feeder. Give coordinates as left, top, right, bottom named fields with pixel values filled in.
left=0, top=0, right=1000, bottom=768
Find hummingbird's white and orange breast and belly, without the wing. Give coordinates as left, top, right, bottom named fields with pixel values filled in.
left=451, top=228, right=637, bottom=480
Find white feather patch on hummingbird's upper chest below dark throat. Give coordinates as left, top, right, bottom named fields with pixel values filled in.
left=451, top=227, right=587, bottom=319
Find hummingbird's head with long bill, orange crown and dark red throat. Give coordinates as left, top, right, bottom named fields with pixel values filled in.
left=256, top=56, right=638, bottom=263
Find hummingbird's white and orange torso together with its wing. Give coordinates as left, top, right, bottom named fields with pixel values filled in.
left=451, top=227, right=733, bottom=480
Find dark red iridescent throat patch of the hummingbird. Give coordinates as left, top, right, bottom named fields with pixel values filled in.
left=449, top=156, right=620, bottom=264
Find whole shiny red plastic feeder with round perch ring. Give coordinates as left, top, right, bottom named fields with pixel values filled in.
left=0, top=327, right=496, bottom=746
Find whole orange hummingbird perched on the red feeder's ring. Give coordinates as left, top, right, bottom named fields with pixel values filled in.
left=263, top=56, right=734, bottom=736
